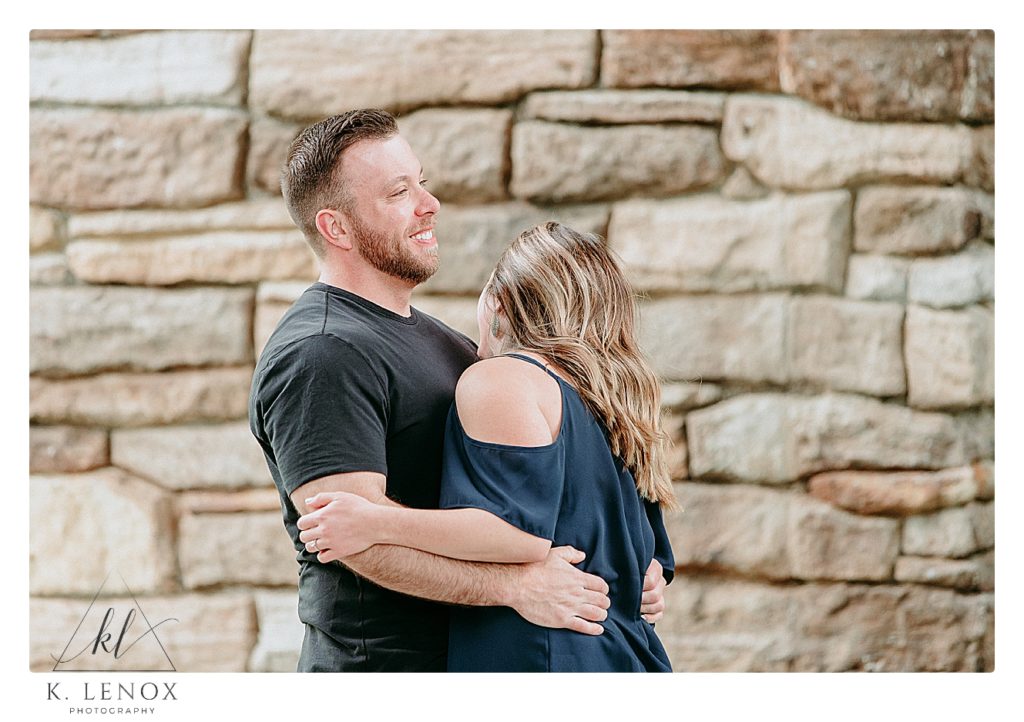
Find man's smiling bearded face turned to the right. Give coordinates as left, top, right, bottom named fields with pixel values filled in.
left=341, top=135, right=440, bottom=286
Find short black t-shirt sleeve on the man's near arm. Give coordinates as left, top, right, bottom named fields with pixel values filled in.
left=252, top=334, right=388, bottom=494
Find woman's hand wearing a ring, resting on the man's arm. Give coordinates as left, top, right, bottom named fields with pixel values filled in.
left=298, top=492, right=383, bottom=562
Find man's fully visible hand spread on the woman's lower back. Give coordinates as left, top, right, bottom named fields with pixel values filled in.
left=509, top=547, right=611, bottom=635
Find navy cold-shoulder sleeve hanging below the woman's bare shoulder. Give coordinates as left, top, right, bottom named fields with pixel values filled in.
left=440, top=404, right=565, bottom=540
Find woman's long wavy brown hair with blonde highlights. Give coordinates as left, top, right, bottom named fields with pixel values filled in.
left=487, top=222, right=678, bottom=509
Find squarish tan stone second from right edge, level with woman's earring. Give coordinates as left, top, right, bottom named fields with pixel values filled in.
left=788, top=296, right=906, bottom=396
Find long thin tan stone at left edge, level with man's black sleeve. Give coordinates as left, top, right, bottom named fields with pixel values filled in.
left=29, top=366, right=252, bottom=426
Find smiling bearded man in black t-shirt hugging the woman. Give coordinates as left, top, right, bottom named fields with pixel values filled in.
left=249, top=110, right=664, bottom=672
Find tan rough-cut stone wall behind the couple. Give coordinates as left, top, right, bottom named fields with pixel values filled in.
left=30, top=30, right=994, bottom=671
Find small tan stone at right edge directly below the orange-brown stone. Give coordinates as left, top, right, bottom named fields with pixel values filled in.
left=902, top=502, right=993, bottom=558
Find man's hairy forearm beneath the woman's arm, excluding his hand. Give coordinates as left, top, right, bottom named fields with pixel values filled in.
left=340, top=544, right=519, bottom=606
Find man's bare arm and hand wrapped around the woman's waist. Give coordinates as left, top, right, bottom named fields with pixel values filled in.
left=290, top=472, right=610, bottom=634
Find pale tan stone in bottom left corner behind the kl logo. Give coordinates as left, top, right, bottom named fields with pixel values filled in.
left=29, top=590, right=256, bottom=671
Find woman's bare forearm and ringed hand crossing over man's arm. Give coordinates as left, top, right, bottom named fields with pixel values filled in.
left=299, top=492, right=551, bottom=562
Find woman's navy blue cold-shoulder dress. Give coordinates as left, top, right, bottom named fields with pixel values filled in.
left=440, top=354, right=675, bottom=672
